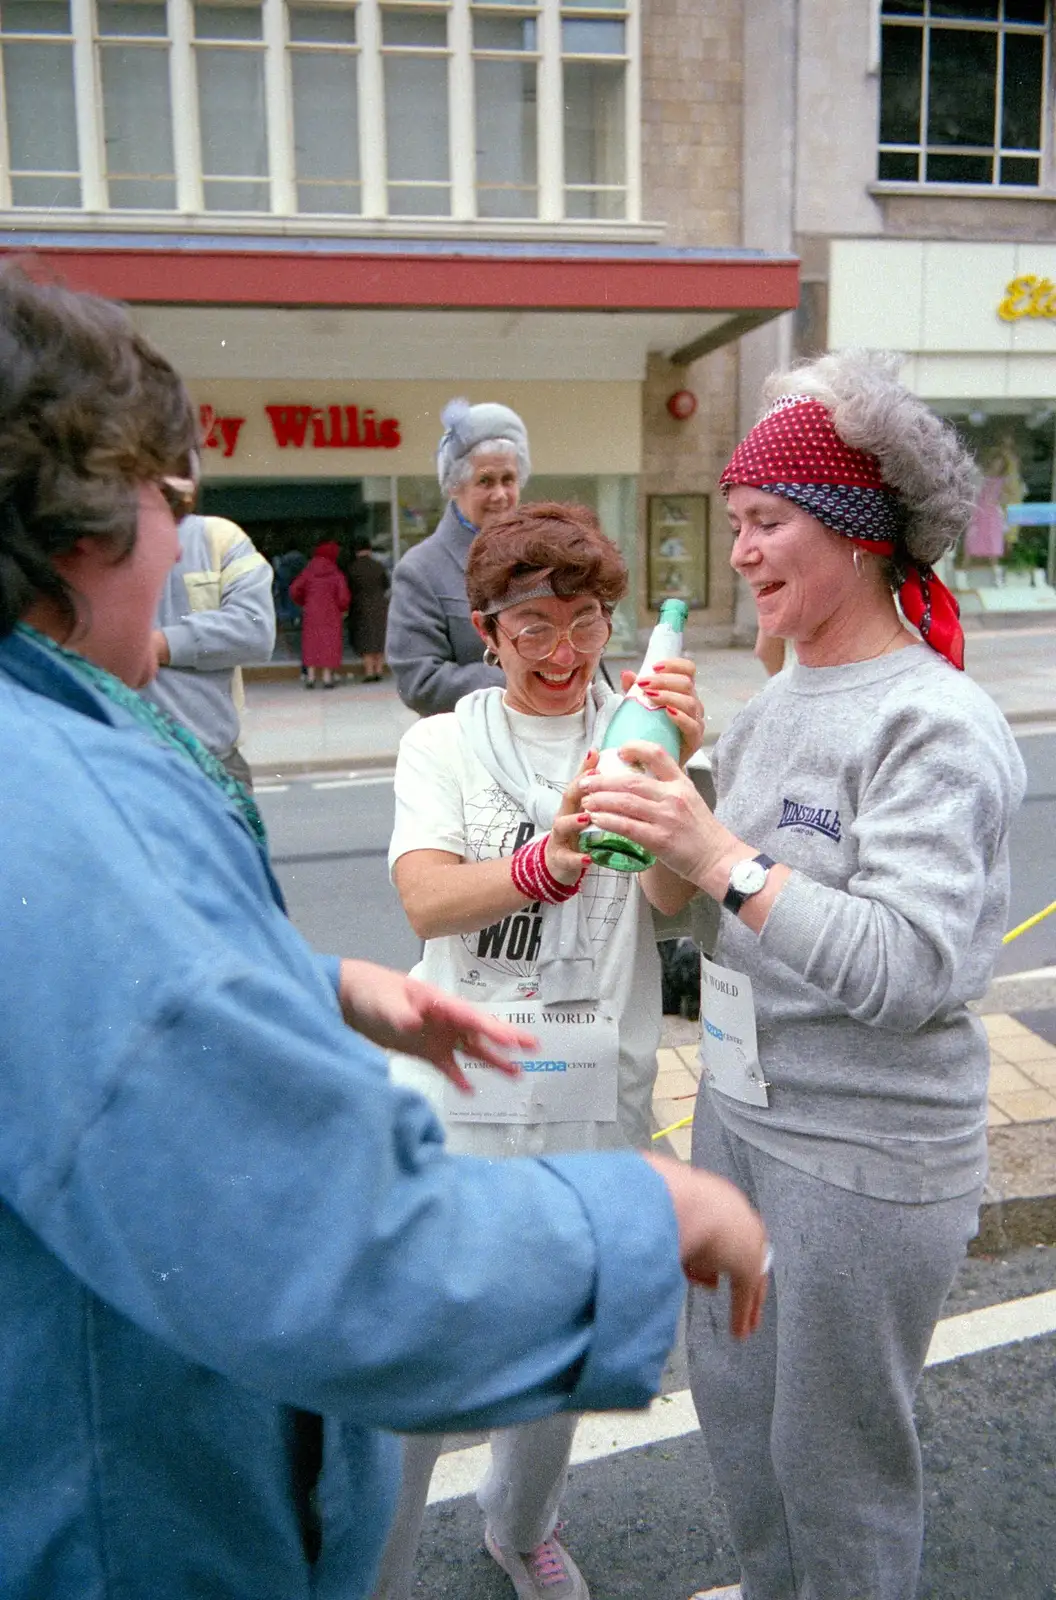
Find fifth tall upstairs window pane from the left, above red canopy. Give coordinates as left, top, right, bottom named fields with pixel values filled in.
left=381, top=3, right=451, bottom=216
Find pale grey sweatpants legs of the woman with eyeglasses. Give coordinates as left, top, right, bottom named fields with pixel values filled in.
left=373, top=1411, right=579, bottom=1600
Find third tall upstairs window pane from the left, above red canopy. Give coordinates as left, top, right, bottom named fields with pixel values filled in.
left=194, top=0, right=270, bottom=211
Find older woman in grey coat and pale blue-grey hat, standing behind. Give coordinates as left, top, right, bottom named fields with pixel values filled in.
left=386, top=400, right=531, bottom=717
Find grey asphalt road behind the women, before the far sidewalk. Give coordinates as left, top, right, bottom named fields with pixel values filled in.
left=258, top=733, right=1056, bottom=973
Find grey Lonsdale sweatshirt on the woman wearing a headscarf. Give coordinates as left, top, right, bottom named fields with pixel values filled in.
left=710, top=645, right=1026, bottom=1202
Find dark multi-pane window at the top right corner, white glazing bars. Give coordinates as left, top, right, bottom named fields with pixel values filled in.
left=878, top=0, right=1048, bottom=189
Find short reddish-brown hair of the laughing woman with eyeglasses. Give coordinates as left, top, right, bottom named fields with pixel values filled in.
left=466, top=501, right=627, bottom=611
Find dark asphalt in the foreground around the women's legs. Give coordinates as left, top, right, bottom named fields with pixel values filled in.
left=400, top=1248, right=1056, bottom=1600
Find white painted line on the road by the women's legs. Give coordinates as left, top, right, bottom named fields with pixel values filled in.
left=429, top=1290, right=1056, bottom=1506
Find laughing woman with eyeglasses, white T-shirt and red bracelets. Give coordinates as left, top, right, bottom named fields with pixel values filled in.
left=374, top=504, right=704, bottom=1600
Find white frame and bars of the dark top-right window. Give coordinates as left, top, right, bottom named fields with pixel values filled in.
left=875, top=0, right=1056, bottom=195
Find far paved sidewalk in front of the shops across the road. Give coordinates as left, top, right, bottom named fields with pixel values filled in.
left=242, top=622, right=1056, bottom=778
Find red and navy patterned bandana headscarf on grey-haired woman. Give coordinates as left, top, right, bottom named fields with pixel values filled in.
left=718, top=395, right=965, bottom=672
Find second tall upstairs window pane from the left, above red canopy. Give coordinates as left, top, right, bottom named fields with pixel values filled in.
left=96, top=0, right=176, bottom=211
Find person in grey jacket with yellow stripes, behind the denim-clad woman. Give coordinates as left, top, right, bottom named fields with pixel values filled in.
left=142, top=478, right=275, bottom=789
